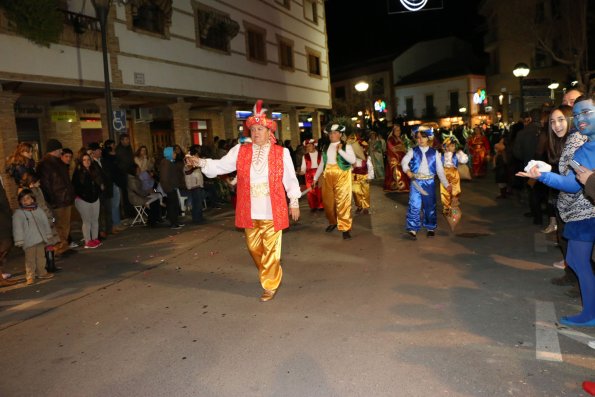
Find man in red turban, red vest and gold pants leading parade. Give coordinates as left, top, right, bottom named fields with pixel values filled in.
left=192, top=100, right=301, bottom=302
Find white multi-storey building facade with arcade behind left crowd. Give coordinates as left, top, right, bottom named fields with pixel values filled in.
left=0, top=0, right=331, bottom=201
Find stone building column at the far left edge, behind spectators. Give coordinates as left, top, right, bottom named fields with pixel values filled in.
left=0, top=86, right=20, bottom=209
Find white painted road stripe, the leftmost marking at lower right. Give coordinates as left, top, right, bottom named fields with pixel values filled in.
left=535, top=301, right=562, bottom=362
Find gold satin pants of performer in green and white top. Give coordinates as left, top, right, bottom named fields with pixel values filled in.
left=322, top=164, right=352, bottom=232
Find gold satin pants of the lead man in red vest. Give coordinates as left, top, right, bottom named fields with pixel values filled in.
left=244, top=220, right=283, bottom=290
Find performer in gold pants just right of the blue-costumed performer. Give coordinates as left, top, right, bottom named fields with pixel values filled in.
left=440, top=134, right=469, bottom=215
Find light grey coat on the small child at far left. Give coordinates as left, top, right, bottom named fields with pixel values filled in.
left=12, top=208, right=52, bottom=249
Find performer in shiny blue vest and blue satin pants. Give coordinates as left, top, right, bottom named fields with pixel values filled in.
left=401, top=126, right=452, bottom=240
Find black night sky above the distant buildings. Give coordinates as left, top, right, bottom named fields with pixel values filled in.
left=325, top=0, right=486, bottom=70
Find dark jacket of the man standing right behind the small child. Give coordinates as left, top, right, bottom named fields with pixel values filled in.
left=37, top=154, right=75, bottom=208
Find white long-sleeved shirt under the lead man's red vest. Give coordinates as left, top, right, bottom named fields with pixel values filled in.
left=201, top=144, right=302, bottom=220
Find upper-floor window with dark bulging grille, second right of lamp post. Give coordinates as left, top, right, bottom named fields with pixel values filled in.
left=195, top=5, right=240, bottom=53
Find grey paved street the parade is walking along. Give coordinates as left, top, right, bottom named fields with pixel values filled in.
left=0, top=177, right=595, bottom=397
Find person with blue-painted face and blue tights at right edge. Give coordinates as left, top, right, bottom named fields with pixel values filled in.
left=517, top=96, right=595, bottom=327
